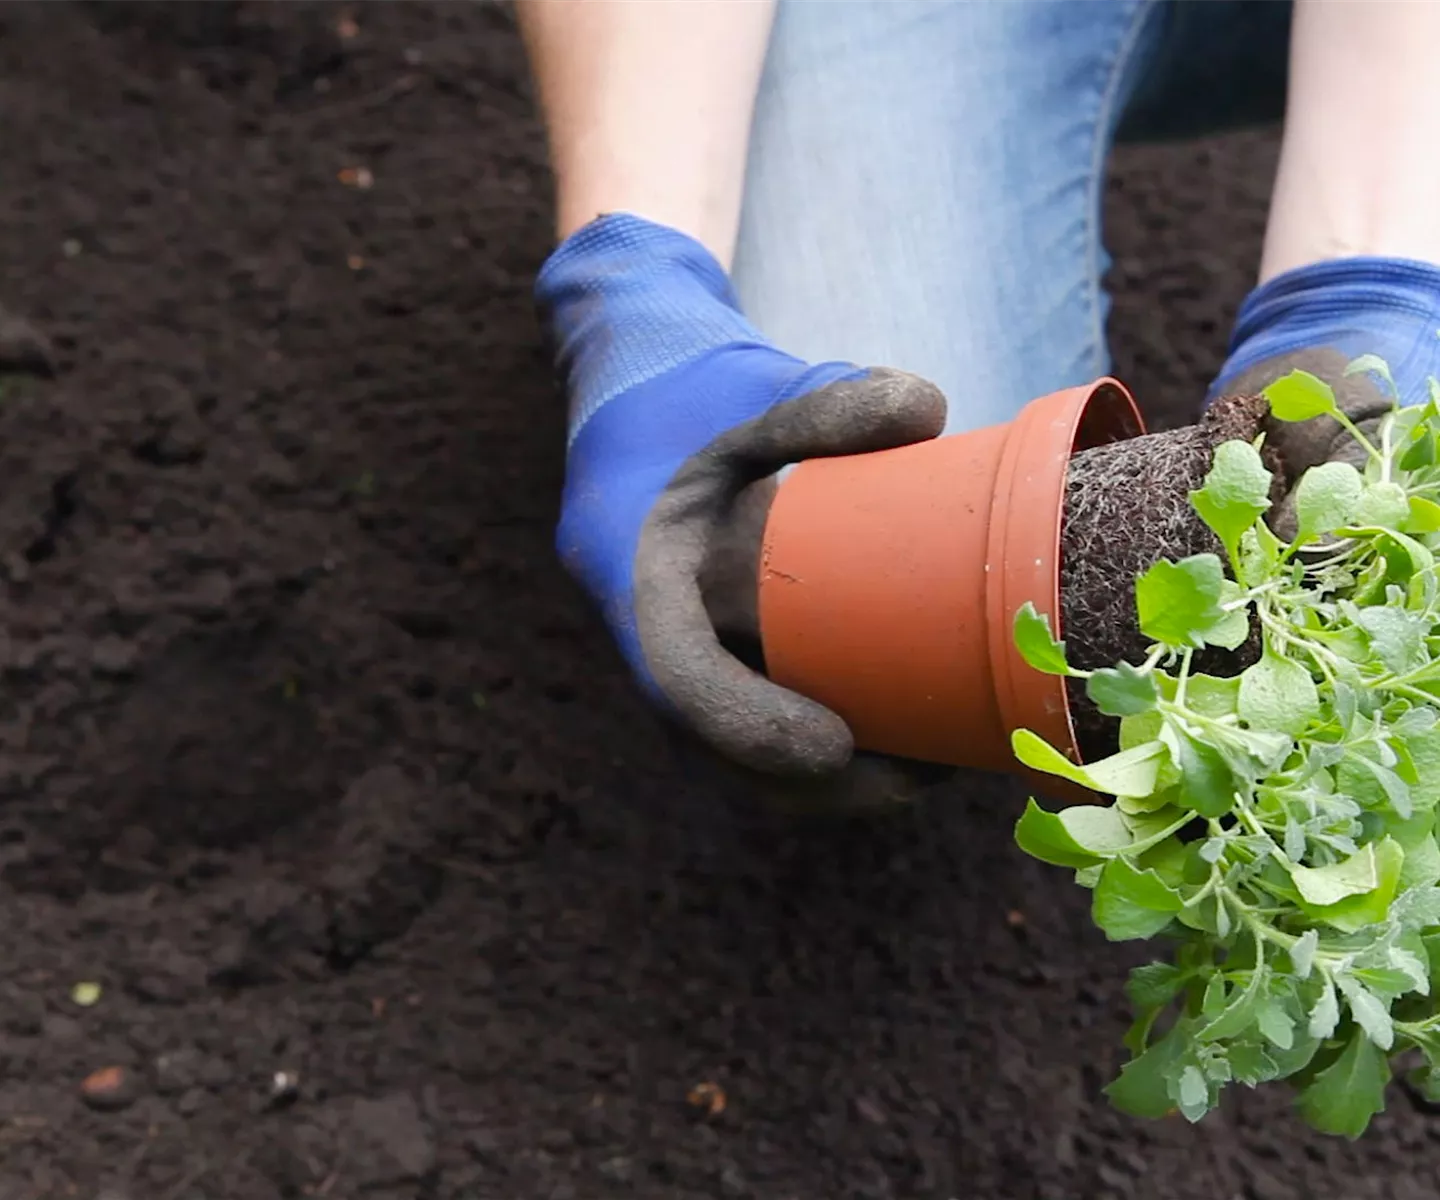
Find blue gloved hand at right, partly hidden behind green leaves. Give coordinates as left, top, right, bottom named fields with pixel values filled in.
left=1207, top=258, right=1440, bottom=534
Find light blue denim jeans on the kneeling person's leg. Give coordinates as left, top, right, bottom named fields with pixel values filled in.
left=734, top=0, right=1290, bottom=432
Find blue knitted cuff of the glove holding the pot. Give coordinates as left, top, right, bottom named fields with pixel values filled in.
left=534, top=213, right=768, bottom=442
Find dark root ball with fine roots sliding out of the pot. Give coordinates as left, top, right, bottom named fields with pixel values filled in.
left=1060, top=396, right=1284, bottom=762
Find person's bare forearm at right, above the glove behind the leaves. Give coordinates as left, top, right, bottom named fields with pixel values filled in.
left=1260, top=0, right=1440, bottom=282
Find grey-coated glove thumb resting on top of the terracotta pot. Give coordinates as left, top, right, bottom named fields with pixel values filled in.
left=725, top=367, right=946, bottom=473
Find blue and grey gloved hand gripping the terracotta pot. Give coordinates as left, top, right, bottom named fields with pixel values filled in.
left=536, top=215, right=945, bottom=788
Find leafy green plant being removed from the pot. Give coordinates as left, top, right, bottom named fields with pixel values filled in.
left=1012, top=356, right=1440, bottom=1137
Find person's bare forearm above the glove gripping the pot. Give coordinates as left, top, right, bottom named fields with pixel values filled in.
left=517, top=0, right=775, bottom=267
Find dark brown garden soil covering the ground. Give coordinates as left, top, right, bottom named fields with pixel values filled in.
left=0, top=0, right=1440, bottom=1200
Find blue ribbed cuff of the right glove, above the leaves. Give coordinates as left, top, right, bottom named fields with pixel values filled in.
left=1210, top=258, right=1440, bottom=403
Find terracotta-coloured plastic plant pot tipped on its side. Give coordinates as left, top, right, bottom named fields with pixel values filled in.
left=759, top=379, right=1145, bottom=784
